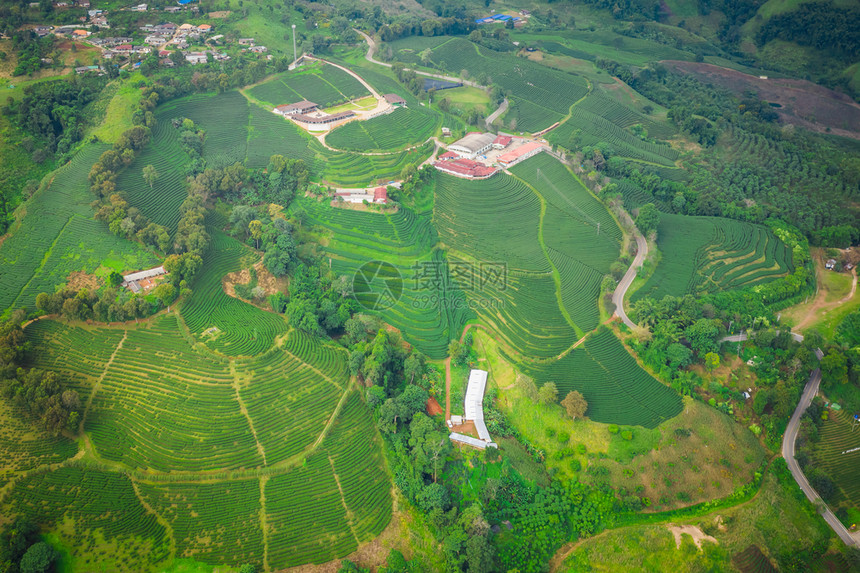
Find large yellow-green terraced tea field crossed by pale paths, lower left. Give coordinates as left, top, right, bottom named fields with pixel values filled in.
left=6, top=316, right=391, bottom=571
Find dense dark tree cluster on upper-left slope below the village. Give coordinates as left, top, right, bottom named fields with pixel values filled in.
left=3, top=77, right=104, bottom=159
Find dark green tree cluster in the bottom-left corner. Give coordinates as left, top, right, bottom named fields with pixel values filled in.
left=0, top=517, right=60, bottom=573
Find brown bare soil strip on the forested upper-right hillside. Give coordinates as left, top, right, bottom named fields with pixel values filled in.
left=662, top=60, right=860, bottom=139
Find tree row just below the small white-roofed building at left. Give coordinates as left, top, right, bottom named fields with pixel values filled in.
left=36, top=284, right=180, bottom=322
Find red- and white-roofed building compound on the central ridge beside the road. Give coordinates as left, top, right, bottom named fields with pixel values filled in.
left=433, top=132, right=549, bottom=179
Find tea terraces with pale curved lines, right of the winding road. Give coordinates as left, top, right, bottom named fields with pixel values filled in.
left=632, top=214, right=794, bottom=301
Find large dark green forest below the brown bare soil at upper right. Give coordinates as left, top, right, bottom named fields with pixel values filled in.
left=624, top=65, right=860, bottom=241
